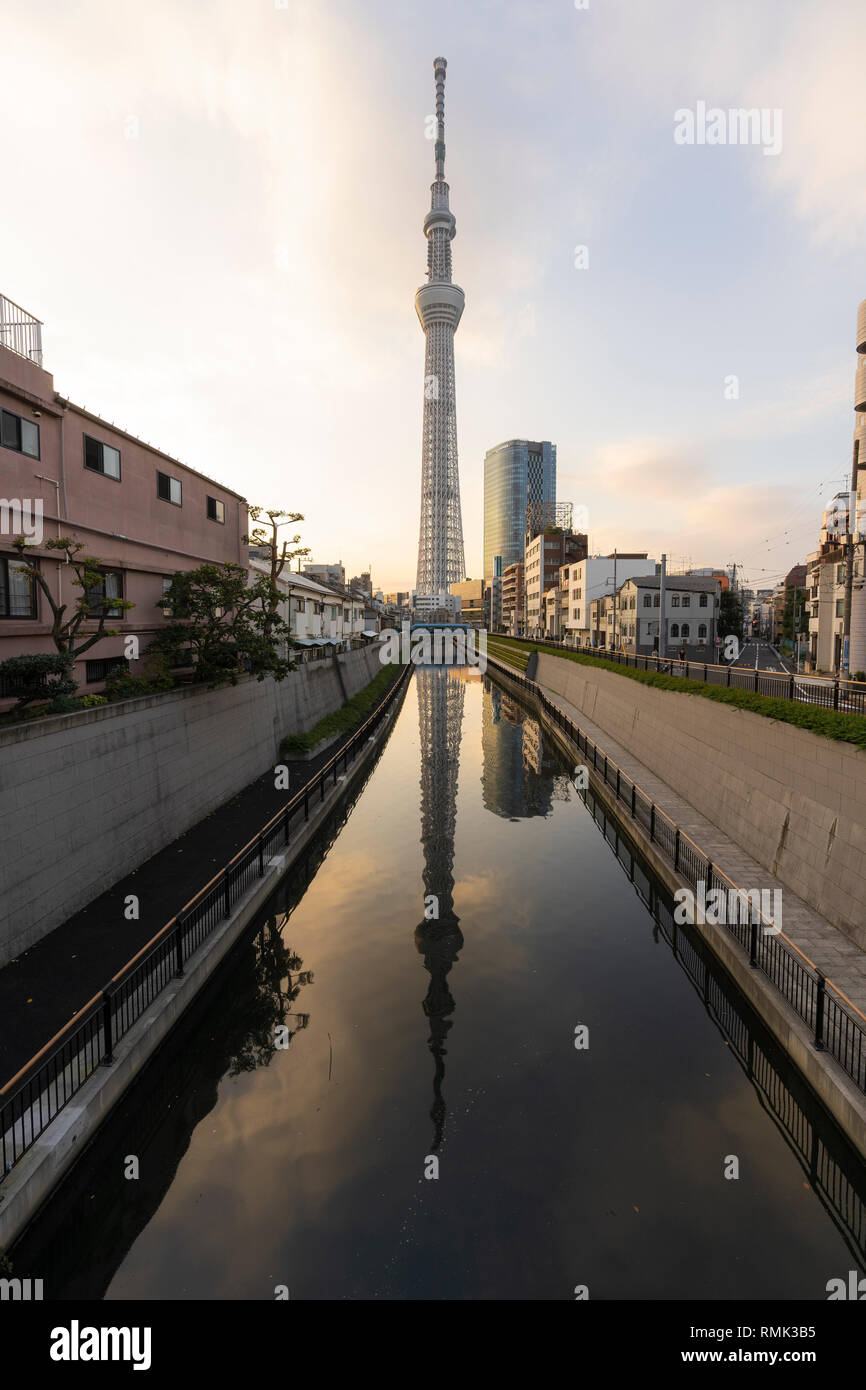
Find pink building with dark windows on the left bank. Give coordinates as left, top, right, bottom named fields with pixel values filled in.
left=0, top=296, right=247, bottom=709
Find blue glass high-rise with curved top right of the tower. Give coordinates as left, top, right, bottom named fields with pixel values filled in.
left=484, top=439, right=556, bottom=582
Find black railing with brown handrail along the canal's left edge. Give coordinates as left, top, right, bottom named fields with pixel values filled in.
left=0, top=664, right=411, bottom=1183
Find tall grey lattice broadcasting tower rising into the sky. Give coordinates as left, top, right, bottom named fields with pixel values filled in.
left=416, top=58, right=466, bottom=595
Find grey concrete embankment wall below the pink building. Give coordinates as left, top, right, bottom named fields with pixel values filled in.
left=0, top=646, right=381, bottom=966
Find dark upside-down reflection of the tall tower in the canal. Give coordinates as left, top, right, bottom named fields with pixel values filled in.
left=416, top=666, right=466, bottom=1151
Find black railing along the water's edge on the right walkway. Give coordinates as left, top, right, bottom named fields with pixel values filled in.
left=487, top=651, right=866, bottom=1091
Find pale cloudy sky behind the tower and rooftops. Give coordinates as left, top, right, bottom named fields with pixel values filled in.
left=0, top=0, right=866, bottom=589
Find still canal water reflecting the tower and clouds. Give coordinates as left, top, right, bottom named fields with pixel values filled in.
left=11, top=669, right=866, bottom=1300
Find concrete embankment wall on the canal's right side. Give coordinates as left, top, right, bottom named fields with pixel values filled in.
left=535, top=652, right=866, bottom=949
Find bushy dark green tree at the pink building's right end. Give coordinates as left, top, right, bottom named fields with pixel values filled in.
left=147, top=563, right=295, bottom=687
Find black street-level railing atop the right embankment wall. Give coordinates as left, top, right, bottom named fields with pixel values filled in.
left=488, top=632, right=866, bottom=714
